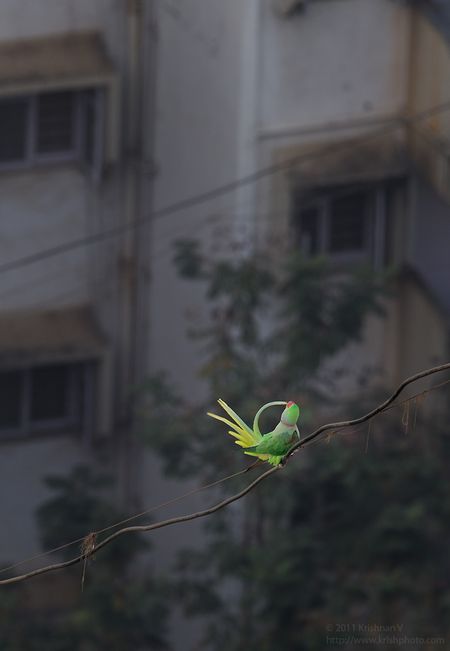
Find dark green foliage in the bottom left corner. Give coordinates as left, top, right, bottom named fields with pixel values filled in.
left=0, top=466, right=168, bottom=651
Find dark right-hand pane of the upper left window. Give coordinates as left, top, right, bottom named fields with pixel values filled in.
left=37, top=91, right=75, bottom=154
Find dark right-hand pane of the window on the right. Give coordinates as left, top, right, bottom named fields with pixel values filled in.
left=330, top=192, right=369, bottom=253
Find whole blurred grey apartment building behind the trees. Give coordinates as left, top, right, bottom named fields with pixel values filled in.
left=0, top=0, right=450, bottom=648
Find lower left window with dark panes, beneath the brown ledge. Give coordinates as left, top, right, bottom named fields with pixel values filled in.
left=0, top=363, right=92, bottom=436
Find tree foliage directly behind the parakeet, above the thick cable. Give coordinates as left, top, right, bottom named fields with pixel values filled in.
left=141, top=241, right=381, bottom=479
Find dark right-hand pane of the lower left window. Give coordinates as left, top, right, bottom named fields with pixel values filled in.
left=30, top=364, right=70, bottom=423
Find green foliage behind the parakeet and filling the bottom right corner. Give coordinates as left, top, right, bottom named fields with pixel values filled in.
left=137, top=242, right=450, bottom=651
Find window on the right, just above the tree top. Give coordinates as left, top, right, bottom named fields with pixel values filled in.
left=294, top=181, right=404, bottom=268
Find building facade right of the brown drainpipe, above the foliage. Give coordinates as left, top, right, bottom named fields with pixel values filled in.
left=150, top=0, right=450, bottom=402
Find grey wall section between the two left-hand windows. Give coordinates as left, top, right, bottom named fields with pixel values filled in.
left=0, top=167, right=91, bottom=311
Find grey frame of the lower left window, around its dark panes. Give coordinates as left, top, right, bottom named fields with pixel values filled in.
left=0, top=360, right=95, bottom=441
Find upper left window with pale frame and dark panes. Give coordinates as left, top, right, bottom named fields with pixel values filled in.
left=0, top=89, right=102, bottom=173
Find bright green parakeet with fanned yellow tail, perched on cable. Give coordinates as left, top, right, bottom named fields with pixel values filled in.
left=208, top=399, right=300, bottom=466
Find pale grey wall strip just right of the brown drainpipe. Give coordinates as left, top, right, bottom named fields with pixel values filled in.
left=144, top=0, right=259, bottom=649
